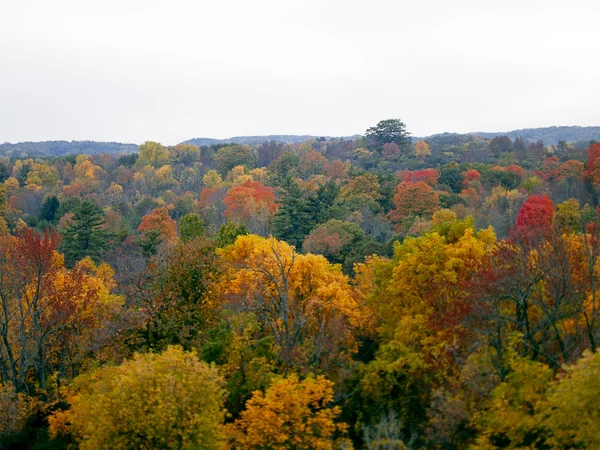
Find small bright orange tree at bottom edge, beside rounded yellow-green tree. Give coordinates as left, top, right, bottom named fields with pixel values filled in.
left=228, top=375, right=348, bottom=450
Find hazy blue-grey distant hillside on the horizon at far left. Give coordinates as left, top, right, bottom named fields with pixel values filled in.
left=0, top=141, right=139, bottom=156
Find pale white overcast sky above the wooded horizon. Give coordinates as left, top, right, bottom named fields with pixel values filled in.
left=0, top=0, right=600, bottom=144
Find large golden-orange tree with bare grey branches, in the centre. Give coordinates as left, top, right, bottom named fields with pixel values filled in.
left=220, top=235, right=360, bottom=370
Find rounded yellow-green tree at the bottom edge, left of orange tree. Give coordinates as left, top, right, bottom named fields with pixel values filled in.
left=50, top=347, right=224, bottom=450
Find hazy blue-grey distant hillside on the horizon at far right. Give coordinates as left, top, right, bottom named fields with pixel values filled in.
left=468, top=126, right=600, bottom=145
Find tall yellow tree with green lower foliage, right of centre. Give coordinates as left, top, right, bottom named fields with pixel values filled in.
left=361, top=220, right=495, bottom=434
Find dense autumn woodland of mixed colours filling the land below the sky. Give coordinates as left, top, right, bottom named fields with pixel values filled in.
left=0, top=119, right=600, bottom=450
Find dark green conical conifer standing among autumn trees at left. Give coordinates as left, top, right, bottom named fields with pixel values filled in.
left=61, top=200, right=111, bottom=267
